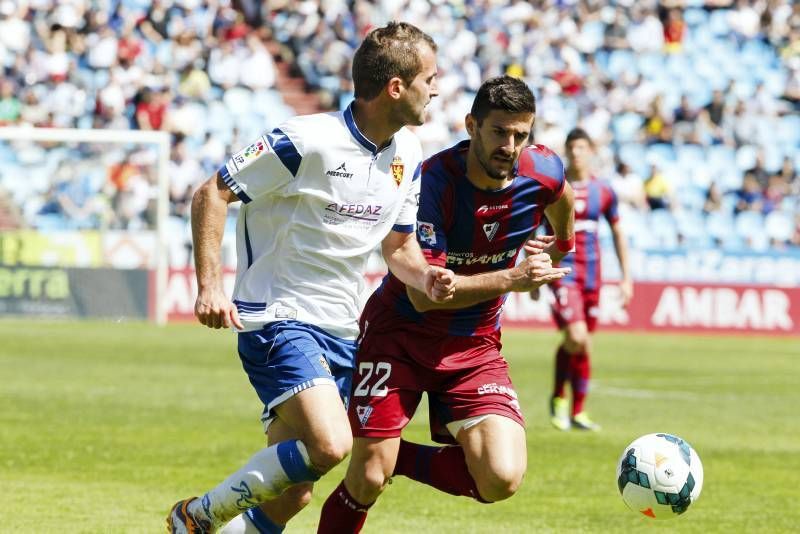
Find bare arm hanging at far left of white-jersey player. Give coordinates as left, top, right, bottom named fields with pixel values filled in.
left=192, top=174, right=244, bottom=329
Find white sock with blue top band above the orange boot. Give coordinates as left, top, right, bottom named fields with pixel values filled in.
left=187, top=440, right=319, bottom=528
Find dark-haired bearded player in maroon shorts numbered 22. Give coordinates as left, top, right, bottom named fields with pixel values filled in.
left=319, top=76, right=573, bottom=533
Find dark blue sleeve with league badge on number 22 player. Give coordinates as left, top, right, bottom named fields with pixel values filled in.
left=417, top=164, right=449, bottom=267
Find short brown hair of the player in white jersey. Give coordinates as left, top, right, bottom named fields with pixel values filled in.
left=353, top=22, right=437, bottom=100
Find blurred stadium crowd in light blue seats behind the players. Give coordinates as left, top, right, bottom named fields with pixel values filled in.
left=0, top=0, right=800, bottom=250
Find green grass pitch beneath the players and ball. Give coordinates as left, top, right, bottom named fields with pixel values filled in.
left=0, top=320, right=800, bottom=534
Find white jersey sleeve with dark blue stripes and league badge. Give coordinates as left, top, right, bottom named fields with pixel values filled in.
left=219, top=123, right=304, bottom=203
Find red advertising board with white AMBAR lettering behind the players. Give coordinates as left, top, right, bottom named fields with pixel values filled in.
left=165, top=269, right=800, bottom=335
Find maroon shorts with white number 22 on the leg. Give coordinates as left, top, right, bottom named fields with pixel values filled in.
left=348, top=299, right=525, bottom=443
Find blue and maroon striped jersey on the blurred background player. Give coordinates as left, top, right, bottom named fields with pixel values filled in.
left=548, top=178, right=619, bottom=291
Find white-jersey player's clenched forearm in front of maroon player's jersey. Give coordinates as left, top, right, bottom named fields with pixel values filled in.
left=381, top=231, right=455, bottom=302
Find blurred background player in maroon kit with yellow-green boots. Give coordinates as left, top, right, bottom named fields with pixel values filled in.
left=532, top=128, right=633, bottom=436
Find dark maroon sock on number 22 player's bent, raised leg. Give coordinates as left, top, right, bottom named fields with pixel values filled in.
left=394, top=439, right=486, bottom=502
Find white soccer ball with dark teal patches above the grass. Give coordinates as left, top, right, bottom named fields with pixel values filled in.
left=617, top=434, right=703, bottom=519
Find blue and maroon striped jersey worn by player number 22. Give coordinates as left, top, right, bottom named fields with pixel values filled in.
left=377, top=140, right=565, bottom=336
